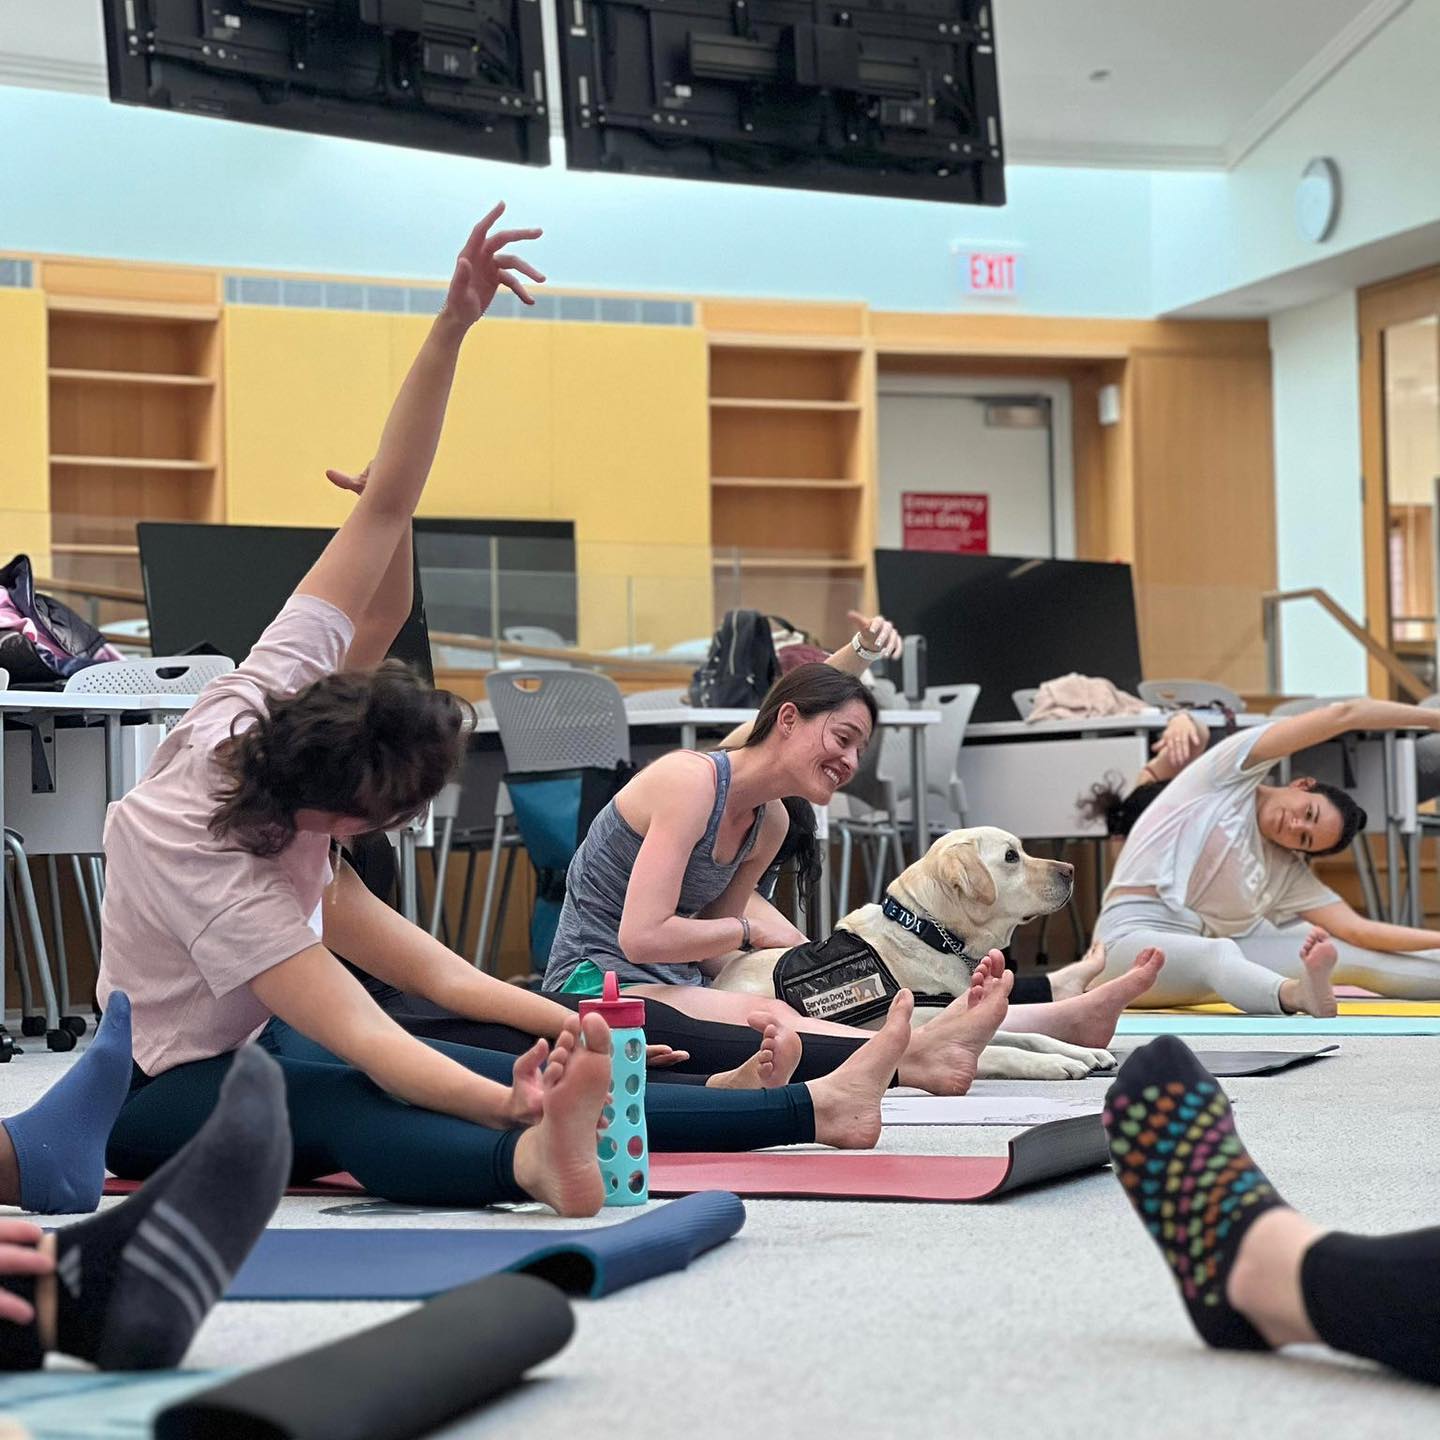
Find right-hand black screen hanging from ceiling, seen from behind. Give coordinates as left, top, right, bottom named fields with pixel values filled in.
left=553, top=0, right=1005, bottom=204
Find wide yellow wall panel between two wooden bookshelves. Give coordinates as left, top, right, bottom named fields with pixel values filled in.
left=225, top=307, right=713, bottom=649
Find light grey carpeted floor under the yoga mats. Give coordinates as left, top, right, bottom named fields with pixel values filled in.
left=0, top=1038, right=1440, bottom=1440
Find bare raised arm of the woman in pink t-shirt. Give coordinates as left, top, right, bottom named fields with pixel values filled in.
left=295, top=204, right=544, bottom=626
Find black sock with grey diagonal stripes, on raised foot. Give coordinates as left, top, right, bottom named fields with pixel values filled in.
left=55, top=1045, right=291, bottom=1369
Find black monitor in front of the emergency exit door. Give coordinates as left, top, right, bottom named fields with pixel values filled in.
left=876, top=550, right=1142, bottom=720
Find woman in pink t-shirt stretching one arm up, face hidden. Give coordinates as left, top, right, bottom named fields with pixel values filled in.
left=99, top=206, right=909, bottom=1214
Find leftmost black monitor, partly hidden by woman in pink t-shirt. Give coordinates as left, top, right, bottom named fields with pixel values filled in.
left=135, top=521, right=435, bottom=684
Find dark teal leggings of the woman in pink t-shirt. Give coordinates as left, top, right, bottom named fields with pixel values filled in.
left=105, top=1020, right=815, bottom=1205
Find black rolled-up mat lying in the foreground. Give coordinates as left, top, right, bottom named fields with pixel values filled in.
left=156, top=1274, right=575, bottom=1440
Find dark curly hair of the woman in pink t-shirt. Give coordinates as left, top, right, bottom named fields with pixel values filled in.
left=210, top=661, right=467, bottom=855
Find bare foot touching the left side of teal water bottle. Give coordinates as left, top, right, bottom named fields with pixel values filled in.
left=516, top=1015, right=611, bottom=1215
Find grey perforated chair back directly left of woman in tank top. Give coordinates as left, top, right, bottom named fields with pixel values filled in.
left=485, top=670, right=631, bottom=773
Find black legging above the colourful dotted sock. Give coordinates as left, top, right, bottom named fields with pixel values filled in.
left=1300, top=1230, right=1440, bottom=1385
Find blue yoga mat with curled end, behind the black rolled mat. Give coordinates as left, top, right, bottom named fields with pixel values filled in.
left=225, top=1191, right=744, bottom=1300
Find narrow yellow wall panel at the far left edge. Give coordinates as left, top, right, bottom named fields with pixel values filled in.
left=0, top=289, right=50, bottom=575
